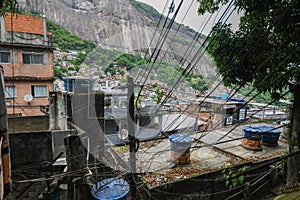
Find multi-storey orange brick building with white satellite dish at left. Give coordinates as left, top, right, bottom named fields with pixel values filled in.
left=0, top=13, right=54, bottom=116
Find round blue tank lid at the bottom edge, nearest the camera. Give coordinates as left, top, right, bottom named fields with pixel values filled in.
left=92, top=178, right=130, bottom=200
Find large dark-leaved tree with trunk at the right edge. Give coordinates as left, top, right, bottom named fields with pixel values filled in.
left=198, top=0, right=300, bottom=187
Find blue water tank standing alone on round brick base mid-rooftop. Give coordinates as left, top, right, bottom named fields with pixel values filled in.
left=169, top=134, right=194, bottom=153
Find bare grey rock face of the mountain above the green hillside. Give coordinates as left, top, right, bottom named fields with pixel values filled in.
left=20, top=0, right=215, bottom=76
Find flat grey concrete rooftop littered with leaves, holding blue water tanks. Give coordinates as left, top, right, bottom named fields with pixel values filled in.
left=115, top=124, right=287, bottom=187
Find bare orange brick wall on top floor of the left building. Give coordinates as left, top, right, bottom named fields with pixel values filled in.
left=4, top=13, right=44, bottom=35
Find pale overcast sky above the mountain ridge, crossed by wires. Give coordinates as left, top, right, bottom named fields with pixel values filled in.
left=138, top=0, right=238, bottom=35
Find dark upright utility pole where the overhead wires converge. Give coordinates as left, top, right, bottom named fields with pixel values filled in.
left=127, top=76, right=138, bottom=200
